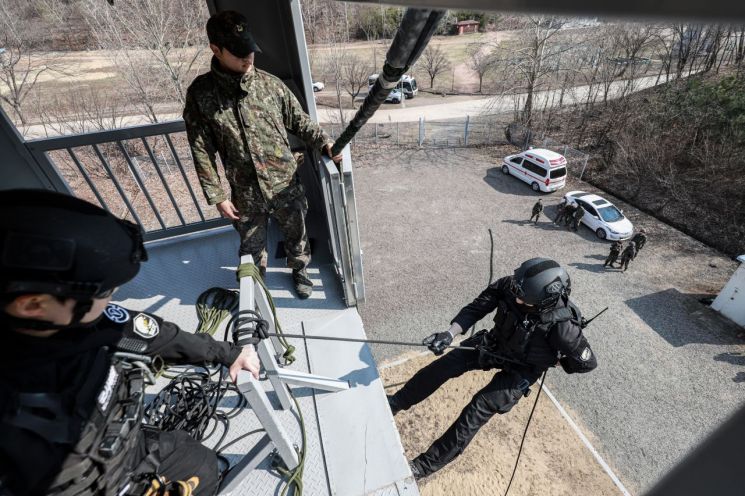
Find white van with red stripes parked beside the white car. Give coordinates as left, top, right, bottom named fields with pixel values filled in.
left=502, top=148, right=567, bottom=193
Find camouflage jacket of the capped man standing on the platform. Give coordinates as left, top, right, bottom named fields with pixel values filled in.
left=184, top=59, right=333, bottom=212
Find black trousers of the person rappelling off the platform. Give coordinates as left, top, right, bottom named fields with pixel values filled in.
left=393, top=344, right=541, bottom=476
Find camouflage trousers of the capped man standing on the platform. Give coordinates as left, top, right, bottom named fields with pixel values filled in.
left=233, top=185, right=310, bottom=270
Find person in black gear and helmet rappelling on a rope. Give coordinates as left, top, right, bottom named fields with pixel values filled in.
left=388, top=258, right=597, bottom=479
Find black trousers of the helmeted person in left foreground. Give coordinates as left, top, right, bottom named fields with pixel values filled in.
left=135, top=430, right=219, bottom=496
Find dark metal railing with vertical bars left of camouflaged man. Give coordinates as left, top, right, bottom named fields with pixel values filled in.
left=25, top=121, right=229, bottom=241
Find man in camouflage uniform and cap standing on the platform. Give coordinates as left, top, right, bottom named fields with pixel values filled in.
left=184, top=11, right=341, bottom=299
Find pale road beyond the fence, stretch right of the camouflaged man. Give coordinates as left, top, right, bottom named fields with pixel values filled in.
left=318, top=76, right=672, bottom=123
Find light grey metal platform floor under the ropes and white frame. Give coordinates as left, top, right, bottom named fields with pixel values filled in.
left=115, top=226, right=419, bottom=496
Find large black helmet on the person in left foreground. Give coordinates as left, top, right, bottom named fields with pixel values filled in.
left=0, top=189, right=147, bottom=328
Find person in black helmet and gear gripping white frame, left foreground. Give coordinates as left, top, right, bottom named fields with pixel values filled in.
left=0, top=190, right=259, bottom=496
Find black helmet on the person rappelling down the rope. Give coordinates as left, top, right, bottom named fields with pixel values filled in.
left=512, top=258, right=572, bottom=310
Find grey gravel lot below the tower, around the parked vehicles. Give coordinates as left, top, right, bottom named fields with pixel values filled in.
left=354, top=143, right=745, bottom=492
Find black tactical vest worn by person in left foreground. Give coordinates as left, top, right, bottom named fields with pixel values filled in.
left=0, top=347, right=150, bottom=496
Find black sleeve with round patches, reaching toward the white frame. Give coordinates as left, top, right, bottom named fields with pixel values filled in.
left=115, top=311, right=241, bottom=365
